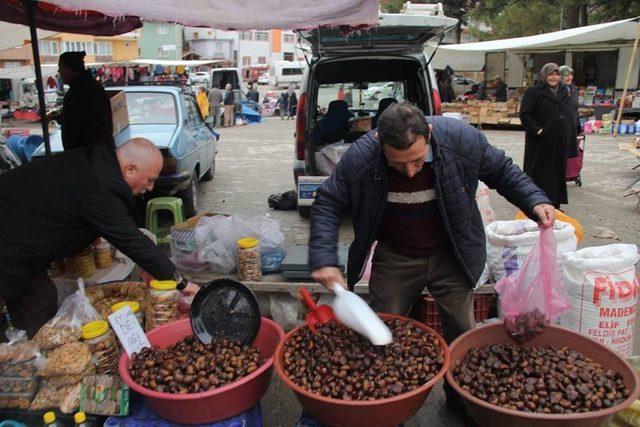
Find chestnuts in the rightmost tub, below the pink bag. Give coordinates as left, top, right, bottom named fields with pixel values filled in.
left=453, top=344, right=629, bottom=414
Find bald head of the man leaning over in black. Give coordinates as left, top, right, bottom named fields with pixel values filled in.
left=116, top=138, right=162, bottom=196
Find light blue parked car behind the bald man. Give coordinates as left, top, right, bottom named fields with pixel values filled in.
left=36, top=86, right=217, bottom=217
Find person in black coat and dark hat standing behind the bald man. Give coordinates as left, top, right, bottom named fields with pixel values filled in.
left=58, top=52, right=114, bottom=150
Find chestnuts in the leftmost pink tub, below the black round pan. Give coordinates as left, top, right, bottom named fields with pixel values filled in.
left=129, top=336, right=260, bottom=394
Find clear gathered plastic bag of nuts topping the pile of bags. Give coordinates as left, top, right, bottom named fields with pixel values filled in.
left=33, top=291, right=99, bottom=350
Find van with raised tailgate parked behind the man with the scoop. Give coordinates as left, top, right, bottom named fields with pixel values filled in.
left=293, top=13, right=457, bottom=215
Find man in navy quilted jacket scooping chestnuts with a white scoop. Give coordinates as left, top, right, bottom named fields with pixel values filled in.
left=309, top=103, right=554, bottom=342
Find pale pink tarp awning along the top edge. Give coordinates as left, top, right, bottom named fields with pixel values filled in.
left=41, top=0, right=378, bottom=30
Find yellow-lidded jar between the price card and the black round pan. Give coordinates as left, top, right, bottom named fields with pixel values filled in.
left=145, top=280, right=180, bottom=331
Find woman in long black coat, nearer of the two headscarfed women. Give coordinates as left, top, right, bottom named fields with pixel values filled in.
left=520, top=63, right=570, bottom=208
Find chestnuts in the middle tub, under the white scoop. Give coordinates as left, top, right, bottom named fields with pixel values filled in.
left=283, top=319, right=444, bottom=400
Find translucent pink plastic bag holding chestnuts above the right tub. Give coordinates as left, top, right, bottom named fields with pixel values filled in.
left=496, top=227, right=571, bottom=343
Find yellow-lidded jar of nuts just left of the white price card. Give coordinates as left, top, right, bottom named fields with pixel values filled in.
left=82, top=320, right=120, bottom=375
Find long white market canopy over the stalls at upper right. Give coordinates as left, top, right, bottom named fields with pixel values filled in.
left=427, top=18, right=640, bottom=70
